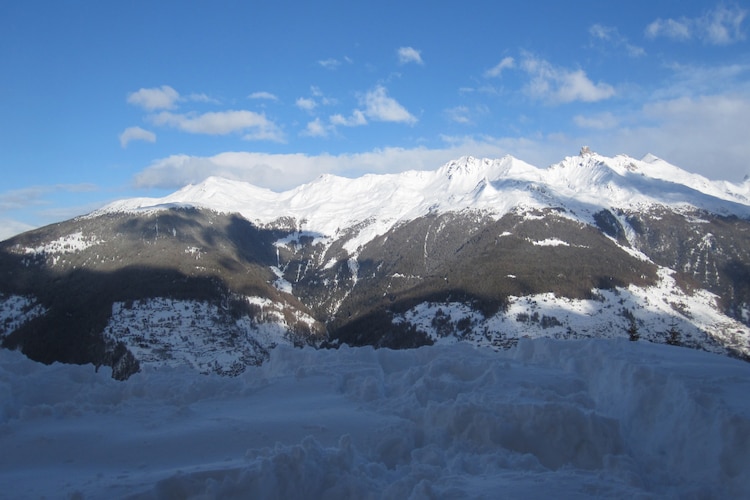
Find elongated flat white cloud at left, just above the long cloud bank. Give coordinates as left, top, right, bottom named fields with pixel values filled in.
left=150, top=110, right=284, bottom=142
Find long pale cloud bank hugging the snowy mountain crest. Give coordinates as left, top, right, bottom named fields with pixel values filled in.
left=135, top=91, right=750, bottom=194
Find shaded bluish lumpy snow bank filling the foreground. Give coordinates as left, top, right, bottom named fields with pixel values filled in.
left=0, top=339, right=750, bottom=499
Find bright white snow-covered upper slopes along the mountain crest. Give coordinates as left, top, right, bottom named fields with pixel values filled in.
left=94, top=152, right=750, bottom=248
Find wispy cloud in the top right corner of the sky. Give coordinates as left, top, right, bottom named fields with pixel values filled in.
left=646, top=5, right=747, bottom=45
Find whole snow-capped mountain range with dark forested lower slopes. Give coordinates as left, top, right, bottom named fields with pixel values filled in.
left=0, top=148, right=750, bottom=376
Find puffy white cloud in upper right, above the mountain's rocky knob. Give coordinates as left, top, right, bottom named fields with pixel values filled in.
left=521, top=55, right=615, bottom=104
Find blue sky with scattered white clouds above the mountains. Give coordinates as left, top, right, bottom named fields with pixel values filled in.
left=0, top=0, right=750, bottom=238
